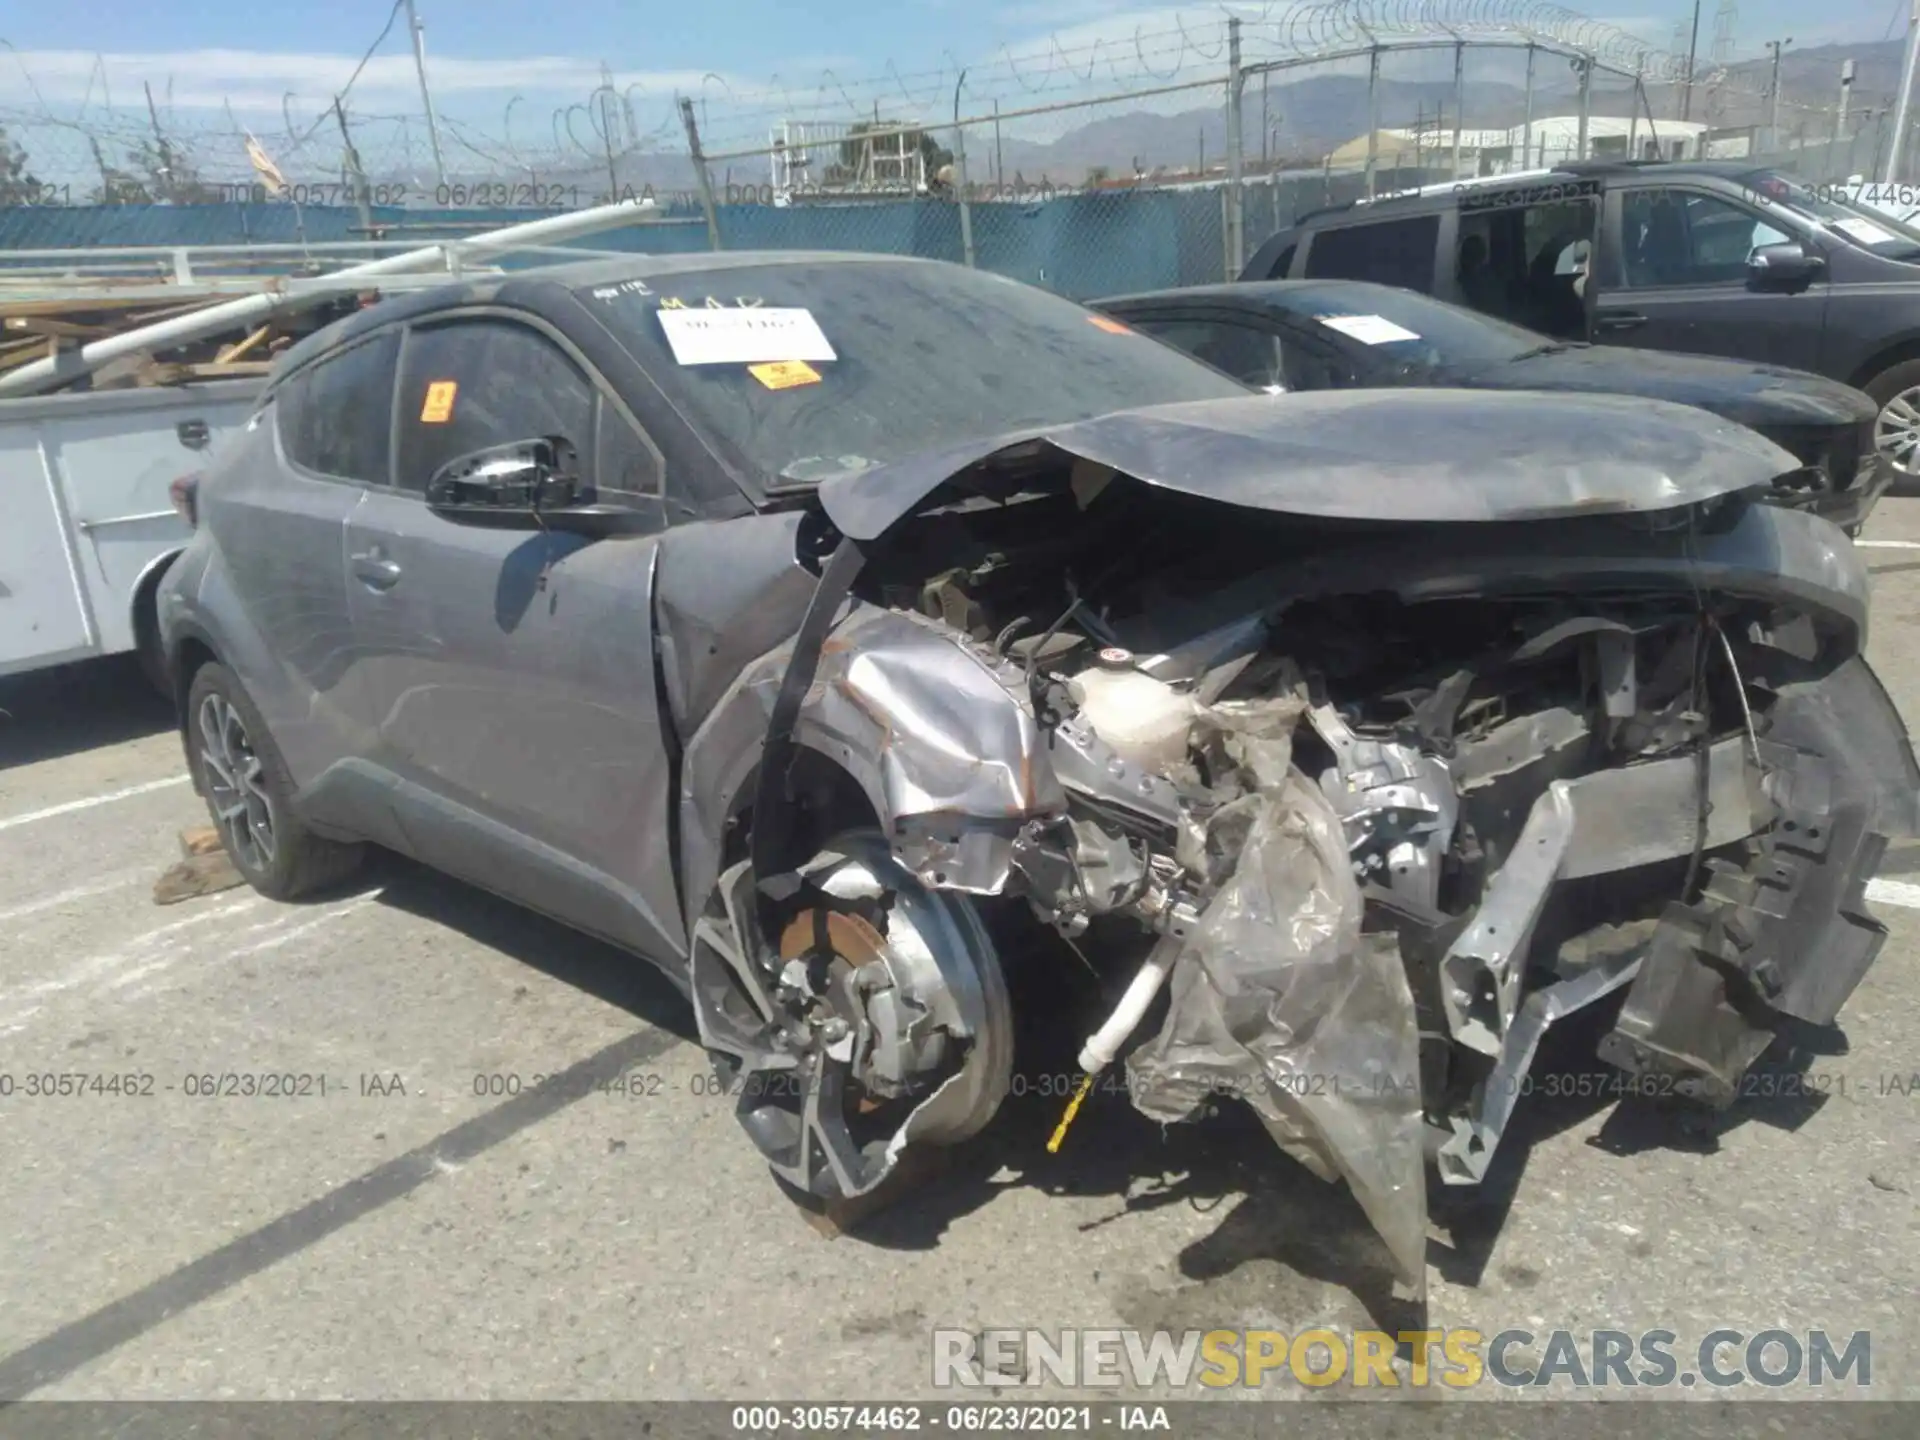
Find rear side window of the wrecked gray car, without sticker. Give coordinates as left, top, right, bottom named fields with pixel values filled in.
left=275, top=330, right=399, bottom=486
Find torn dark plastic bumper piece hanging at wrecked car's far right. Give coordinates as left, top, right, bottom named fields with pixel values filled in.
left=1601, top=660, right=1920, bottom=1106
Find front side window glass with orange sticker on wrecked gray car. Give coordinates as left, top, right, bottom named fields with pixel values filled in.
left=396, top=319, right=595, bottom=492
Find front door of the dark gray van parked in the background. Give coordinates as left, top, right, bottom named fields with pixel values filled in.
left=1594, top=184, right=1830, bottom=369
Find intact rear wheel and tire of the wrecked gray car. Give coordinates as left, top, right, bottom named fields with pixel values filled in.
left=186, top=664, right=367, bottom=900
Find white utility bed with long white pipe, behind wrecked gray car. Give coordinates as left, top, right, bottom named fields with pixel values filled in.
left=0, top=202, right=699, bottom=676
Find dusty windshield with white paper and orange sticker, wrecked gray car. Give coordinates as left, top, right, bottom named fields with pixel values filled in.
left=580, top=259, right=1248, bottom=490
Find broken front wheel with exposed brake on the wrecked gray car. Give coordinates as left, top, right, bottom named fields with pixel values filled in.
left=691, top=831, right=1014, bottom=1198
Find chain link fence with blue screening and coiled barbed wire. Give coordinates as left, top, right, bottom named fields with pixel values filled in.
left=0, top=15, right=1912, bottom=298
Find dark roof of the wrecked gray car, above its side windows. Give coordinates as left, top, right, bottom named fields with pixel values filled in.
left=269, top=250, right=948, bottom=390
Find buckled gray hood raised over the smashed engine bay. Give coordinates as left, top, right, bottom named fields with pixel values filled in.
left=820, top=390, right=1797, bottom=541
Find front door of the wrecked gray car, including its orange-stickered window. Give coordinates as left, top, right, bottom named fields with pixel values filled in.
left=348, top=311, right=684, bottom=958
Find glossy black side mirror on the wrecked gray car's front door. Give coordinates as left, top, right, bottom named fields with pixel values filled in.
left=426, top=436, right=639, bottom=536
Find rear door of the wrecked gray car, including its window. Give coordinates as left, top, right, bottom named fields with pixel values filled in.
left=202, top=328, right=399, bottom=814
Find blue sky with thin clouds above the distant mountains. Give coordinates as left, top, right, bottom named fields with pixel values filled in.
left=0, top=0, right=1903, bottom=150
